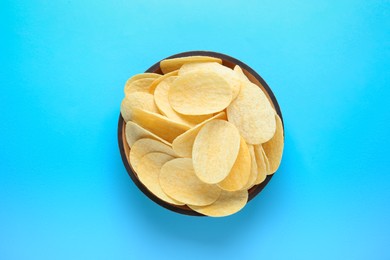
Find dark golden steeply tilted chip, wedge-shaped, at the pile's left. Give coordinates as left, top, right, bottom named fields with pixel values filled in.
left=132, top=108, right=190, bottom=143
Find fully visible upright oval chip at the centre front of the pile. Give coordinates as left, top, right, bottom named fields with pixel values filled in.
left=190, top=119, right=240, bottom=183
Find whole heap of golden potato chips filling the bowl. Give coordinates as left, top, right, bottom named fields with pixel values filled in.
left=121, top=56, right=284, bottom=217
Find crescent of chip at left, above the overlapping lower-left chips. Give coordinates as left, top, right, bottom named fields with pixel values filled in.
left=129, top=138, right=177, bottom=171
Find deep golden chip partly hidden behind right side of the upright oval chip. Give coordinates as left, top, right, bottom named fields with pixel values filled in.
left=218, top=137, right=251, bottom=191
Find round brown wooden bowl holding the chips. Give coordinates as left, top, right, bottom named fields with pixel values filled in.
left=118, top=51, right=283, bottom=216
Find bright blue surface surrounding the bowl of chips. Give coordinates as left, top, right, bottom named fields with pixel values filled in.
left=0, top=0, right=390, bottom=260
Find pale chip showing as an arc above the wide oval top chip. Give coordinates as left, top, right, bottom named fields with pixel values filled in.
left=179, top=62, right=241, bottom=99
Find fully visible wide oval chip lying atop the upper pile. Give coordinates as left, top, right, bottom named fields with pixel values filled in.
left=169, top=72, right=232, bottom=115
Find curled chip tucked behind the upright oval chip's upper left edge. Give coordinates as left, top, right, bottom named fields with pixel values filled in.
left=172, top=112, right=226, bottom=158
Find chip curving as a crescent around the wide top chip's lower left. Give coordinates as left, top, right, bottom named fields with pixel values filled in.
left=154, top=76, right=213, bottom=126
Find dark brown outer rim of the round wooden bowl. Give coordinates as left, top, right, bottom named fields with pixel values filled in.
left=118, top=51, right=284, bottom=216
